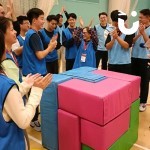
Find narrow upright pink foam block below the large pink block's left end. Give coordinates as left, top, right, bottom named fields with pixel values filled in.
left=58, top=109, right=81, bottom=150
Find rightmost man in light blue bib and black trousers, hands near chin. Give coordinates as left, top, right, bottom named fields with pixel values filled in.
left=131, top=9, right=150, bottom=111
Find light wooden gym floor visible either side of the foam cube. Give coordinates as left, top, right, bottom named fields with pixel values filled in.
left=27, top=84, right=150, bottom=150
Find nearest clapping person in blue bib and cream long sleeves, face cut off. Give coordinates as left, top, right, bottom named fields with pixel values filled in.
left=0, top=31, right=52, bottom=150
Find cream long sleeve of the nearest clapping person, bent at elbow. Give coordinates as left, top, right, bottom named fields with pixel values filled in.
left=4, top=86, right=43, bottom=129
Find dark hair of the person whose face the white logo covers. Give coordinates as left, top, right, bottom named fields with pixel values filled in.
left=110, top=10, right=128, bottom=22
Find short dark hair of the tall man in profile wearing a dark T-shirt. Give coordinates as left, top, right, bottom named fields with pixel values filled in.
left=27, top=8, right=44, bottom=24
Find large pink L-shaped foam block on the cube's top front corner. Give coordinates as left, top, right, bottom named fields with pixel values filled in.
left=58, top=78, right=131, bottom=125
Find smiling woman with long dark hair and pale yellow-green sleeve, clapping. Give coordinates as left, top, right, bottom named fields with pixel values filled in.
left=0, top=17, right=32, bottom=96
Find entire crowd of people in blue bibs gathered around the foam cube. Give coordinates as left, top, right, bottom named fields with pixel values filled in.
left=0, top=2, right=150, bottom=150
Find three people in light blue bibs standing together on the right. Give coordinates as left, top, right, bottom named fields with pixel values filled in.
left=95, top=9, right=150, bottom=112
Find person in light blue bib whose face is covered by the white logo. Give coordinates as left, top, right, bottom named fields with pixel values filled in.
left=105, top=10, right=135, bottom=74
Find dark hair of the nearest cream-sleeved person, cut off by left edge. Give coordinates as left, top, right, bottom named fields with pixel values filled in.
left=0, top=30, right=5, bottom=72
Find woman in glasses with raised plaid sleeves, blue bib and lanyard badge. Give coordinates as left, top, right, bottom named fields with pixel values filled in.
left=73, top=27, right=98, bottom=68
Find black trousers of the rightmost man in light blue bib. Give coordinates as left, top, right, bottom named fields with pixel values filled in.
left=131, top=58, right=150, bottom=103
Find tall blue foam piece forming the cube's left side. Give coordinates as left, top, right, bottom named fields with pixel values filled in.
left=40, top=74, right=72, bottom=150
